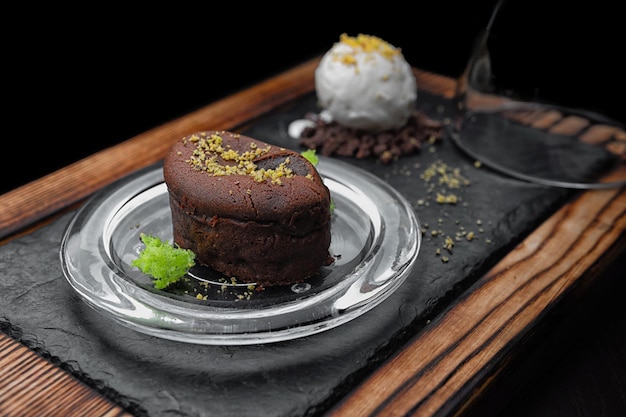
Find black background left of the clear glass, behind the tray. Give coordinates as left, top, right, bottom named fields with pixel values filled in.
left=6, top=0, right=494, bottom=191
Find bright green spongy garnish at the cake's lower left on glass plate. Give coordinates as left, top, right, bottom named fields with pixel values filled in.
left=130, top=233, right=196, bottom=290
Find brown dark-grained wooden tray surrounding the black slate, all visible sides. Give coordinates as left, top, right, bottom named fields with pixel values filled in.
left=0, top=59, right=626, bottom=417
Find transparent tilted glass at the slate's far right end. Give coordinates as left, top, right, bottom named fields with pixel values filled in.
left=452, top=0, right=626, bottom=189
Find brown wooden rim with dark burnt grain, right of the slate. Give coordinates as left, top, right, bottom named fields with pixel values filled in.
left=324, top=166, right=626, bottom=416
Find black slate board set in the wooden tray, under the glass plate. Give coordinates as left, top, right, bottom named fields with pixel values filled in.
left=0, top=91, right=571, bottom=417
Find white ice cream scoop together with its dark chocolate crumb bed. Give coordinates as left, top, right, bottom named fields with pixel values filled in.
left=290, top=33, right=443, bottom=164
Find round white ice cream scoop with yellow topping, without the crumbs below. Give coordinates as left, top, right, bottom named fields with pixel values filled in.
left=315, top=34, right=417, bottom=131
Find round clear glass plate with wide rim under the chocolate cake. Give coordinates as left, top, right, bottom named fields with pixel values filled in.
left=60, top=157, right=421, bottom=345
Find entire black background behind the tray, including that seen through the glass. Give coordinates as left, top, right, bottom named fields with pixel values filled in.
left=0, top=0, right=623, bottom=192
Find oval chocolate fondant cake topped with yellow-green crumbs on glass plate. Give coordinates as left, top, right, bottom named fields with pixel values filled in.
left=163, top=131, right=333, bottom=286
